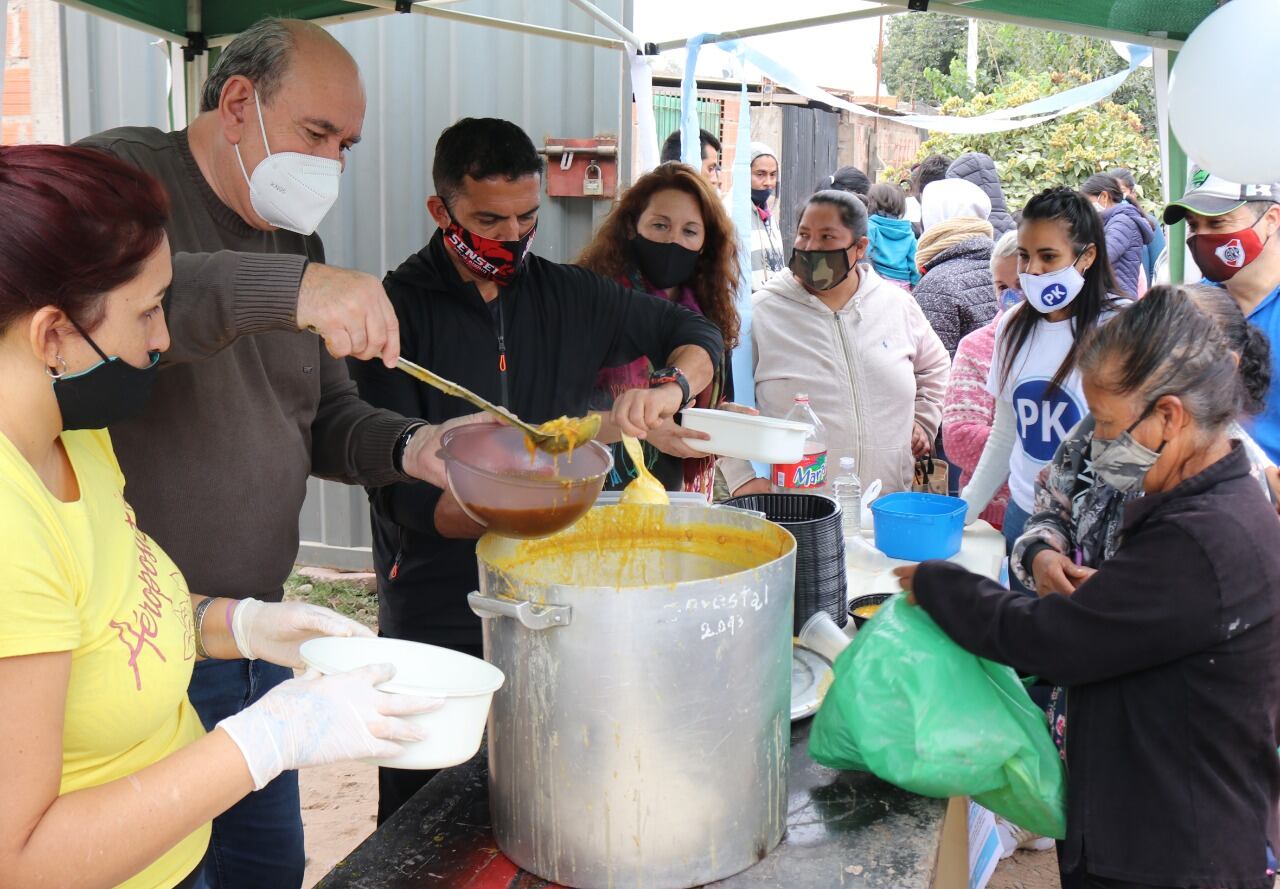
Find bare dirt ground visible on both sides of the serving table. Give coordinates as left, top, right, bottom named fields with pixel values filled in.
left=300, top=762, right=1060, bottom=889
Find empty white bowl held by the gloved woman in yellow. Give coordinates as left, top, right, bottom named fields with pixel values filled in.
left=301, top=637, right=506, bottom=769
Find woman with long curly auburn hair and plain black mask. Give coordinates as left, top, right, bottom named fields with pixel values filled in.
left=577, top=164, right=739, bottom=496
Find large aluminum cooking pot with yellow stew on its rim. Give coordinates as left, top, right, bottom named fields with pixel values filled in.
left=470, top=507, right=795, bottom=889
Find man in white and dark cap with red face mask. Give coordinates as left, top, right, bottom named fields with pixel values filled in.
left=1165, top=168, right=1280, bottom=463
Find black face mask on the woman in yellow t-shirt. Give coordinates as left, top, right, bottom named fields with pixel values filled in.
left=49, top=321, right=160, bottom=431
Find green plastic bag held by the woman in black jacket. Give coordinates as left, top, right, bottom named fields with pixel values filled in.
left=809, top=595, right=1066, bottom=839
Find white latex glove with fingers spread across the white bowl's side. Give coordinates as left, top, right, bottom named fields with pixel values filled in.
left=218, top=664, right=442, bottom=791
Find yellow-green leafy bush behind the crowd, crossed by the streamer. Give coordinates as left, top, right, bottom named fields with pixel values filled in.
left=901, top=72, right=1160, bottom=208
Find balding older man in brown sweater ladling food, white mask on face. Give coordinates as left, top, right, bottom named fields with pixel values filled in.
left=77, top=20, right=465, bottom=889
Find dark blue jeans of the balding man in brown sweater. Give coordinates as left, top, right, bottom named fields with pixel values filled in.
left=187, top=660, right=306, bottom=889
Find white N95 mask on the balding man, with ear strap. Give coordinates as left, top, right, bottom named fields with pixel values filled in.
left=236, top=91, right=342, bottom=234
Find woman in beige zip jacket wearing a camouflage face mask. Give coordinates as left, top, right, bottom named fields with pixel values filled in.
left=721, top=191, right=951, bottom=495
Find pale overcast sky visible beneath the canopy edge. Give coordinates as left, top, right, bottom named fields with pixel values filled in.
left=634, top=0, right=878, bottom=96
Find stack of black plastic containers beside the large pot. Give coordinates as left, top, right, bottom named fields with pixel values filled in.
left=724, top=494, right=849, bottom=634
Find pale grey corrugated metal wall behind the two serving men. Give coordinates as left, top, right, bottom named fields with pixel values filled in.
left=64, top=0, right=632, bottom=568
